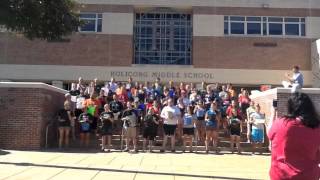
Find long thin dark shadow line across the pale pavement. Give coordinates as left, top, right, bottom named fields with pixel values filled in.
left=0, top=162, right=262, bottom=180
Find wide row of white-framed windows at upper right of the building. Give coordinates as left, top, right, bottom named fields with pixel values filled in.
left=224, top=16, right=305, bottom=36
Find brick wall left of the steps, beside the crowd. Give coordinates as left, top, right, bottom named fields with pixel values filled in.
left=0, top=83, right=65, bottom=150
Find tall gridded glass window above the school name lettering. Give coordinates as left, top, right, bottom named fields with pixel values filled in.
left=134, top=9, right=192, bottom=65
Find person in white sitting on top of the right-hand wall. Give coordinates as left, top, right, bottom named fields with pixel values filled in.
left=282, top=66, right=303, bottom=92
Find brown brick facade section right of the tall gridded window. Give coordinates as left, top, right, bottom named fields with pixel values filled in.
left=193, top=37, right=311, bottom=70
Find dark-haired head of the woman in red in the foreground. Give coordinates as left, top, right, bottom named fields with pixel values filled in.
left=287, top=92, right=320, bottom=128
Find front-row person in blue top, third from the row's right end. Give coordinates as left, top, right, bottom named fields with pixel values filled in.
left=205, top=101, right=221, bottom=153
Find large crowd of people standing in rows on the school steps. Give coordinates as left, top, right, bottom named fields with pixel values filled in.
left=59, top=77, right=265, bottom=153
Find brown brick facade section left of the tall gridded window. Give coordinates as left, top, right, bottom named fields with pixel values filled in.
left=0, top=33, right=133, bottom=66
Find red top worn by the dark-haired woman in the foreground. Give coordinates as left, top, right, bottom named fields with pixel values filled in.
left=268, top=117, right=320, bottom=180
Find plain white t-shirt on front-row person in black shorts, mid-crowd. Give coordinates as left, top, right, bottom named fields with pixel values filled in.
left=160, top=106, right=181, bottom=125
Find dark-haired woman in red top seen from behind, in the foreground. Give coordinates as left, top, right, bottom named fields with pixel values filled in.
left=268, top=93, right=320, bottom=180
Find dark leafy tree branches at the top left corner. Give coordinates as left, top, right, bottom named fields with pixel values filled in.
left=0, top=0, right=80, bottom=40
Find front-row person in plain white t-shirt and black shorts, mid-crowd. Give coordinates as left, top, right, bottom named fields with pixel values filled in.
left=160, top=98, right=181, bottom=152
